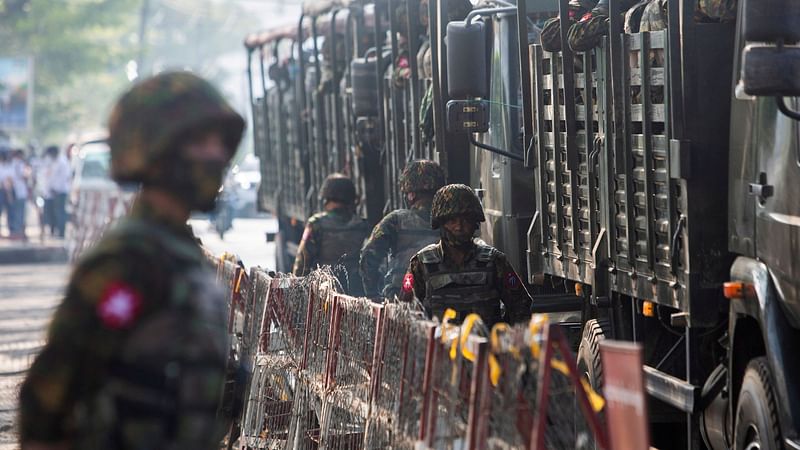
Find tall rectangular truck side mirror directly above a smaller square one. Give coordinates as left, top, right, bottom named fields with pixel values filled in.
left=447, top=21, right=489, bottom=99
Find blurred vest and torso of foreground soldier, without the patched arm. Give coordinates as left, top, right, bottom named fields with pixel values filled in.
left=77, top=219, right=229, bottom=449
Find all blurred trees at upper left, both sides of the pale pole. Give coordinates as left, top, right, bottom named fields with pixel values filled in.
left=0, top=0, right=257, bottom=142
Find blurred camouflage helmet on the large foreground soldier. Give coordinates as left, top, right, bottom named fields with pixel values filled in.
left=108, top=72, right=244, bottom=182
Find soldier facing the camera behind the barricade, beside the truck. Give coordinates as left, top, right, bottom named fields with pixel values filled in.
left=400, top=184, right=531, bottom=328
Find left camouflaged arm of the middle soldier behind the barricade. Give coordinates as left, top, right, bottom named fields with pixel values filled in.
left=359, top=213, right=397, bottom=297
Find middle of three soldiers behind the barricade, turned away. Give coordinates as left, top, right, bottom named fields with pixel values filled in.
left=361, top=160, right=444, bottom=298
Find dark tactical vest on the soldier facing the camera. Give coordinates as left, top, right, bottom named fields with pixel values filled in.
left=418, top=244, right=502, bottom=328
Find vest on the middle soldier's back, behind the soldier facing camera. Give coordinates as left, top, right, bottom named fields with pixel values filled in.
left=383, top=209, right=439, bottom=297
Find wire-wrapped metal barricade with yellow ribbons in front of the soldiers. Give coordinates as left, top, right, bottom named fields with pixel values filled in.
left=230, top=265, right=608, bottom=449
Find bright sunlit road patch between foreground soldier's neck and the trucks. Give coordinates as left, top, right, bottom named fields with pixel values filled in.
left=189, top=218, right=278, bottom=270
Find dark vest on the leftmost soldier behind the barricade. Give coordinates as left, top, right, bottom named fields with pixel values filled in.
left=316, top=214, right=369, bottom=296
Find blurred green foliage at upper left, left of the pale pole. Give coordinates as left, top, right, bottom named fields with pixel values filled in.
left=0, top=0, right=137, bottom=140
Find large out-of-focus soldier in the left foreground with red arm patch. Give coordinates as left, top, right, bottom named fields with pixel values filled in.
left=19, top=72, right=244, bottom=449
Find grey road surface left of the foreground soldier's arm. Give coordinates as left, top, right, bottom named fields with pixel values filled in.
left=0, top=264, right=69, bottom=450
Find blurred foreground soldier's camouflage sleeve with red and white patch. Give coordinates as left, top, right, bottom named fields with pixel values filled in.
left=19, top=251, right=163, bottom=449
